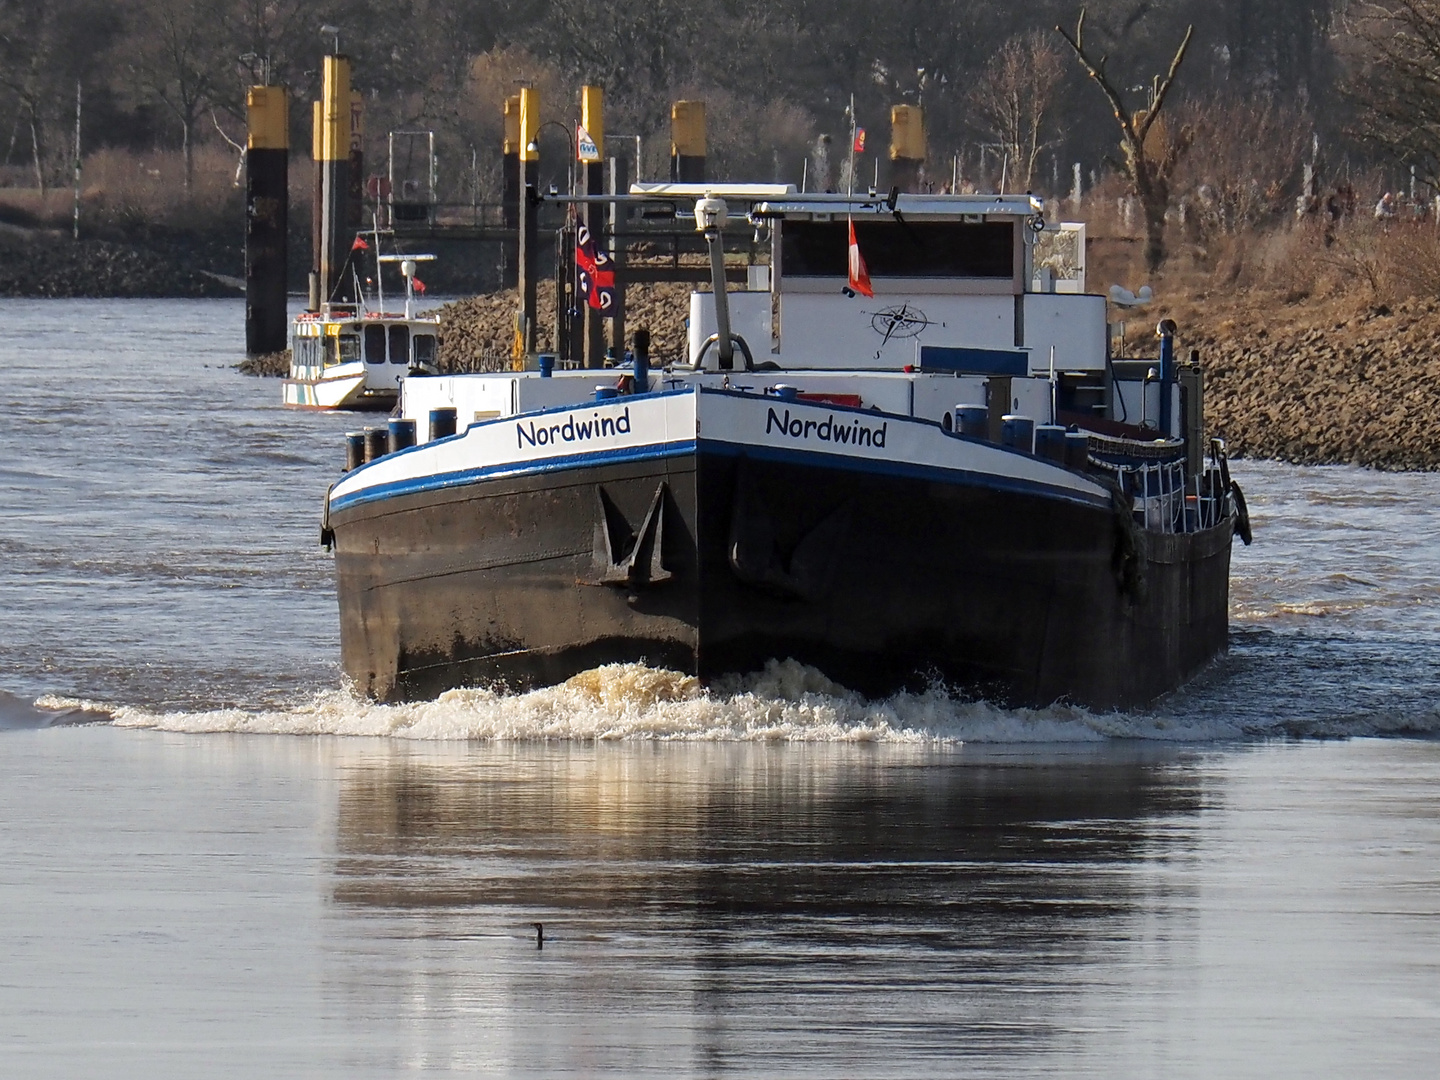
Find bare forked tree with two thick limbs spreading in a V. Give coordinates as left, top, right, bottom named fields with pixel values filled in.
left=1056, top=9, right=1195, bottom=274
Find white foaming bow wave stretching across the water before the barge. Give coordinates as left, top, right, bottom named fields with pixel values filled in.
left=36, top=661, right=1440, bottom=744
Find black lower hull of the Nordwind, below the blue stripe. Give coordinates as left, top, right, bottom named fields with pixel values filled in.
left=327, top=442, right=1231, bottom=708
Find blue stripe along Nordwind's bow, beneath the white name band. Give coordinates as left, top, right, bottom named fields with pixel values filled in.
left=330, top=439, right=1110, bottom=513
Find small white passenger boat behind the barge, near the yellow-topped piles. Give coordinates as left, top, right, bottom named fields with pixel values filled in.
left=282, top=244, right=439, bottom=412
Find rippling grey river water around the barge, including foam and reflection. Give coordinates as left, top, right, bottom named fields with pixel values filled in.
left=0, top=301, right=1440, bottom=1077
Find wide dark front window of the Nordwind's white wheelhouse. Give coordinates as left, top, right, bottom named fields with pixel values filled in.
left=780, top=217, right=1015, bottom=281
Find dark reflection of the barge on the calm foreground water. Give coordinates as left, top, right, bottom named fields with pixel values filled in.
left=331, top=746, right=1204, bottom=1074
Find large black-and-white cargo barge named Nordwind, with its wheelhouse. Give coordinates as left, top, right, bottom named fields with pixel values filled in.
left=323, top=187, right=1248, bottom=708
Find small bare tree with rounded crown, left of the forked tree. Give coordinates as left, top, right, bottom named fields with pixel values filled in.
left=973, top=30, right=1064, bottom=192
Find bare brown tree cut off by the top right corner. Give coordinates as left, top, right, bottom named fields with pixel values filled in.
left=1348, top=0, right=1440, bottom=189
